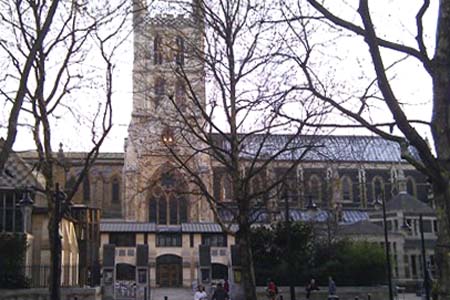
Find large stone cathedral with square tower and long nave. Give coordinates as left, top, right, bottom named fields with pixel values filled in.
left=0, top=0, right=436, bottom=299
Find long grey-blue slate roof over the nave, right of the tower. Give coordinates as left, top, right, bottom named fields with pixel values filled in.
left=215, top=134, right=418, bottom=162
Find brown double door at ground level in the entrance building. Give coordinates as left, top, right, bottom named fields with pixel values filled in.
left=156, top=254, right=183, bottom=287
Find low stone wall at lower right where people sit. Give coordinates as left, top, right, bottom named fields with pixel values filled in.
left=256, top=286, right=389, bottom=300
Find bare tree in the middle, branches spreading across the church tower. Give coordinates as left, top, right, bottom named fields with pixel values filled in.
left=130, top=0, right=326, bottom=300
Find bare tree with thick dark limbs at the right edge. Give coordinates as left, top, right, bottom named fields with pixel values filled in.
left=282, top=0, right=450, bottom=299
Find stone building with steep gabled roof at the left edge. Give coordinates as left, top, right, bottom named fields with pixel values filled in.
left=0, top=140, right=79, bottom=287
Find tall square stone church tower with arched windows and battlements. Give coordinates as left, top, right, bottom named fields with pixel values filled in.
left=123, top=0, right=213, bottom=225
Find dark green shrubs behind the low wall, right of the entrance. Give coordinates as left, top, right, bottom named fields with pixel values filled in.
left=251, top=223, right=386, bottom=286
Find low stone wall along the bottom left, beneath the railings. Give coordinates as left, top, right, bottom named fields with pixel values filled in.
left=0, top=287, right=102, bottom=300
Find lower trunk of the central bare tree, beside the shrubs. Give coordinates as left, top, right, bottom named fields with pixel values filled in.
left=237, top=224, right=256, bottom=300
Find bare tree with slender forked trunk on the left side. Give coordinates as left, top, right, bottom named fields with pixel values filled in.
left=0, top=1, right=127, bottom=300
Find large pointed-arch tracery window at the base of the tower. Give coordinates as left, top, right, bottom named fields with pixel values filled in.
left=148, top=163, right=189, bottom=225
